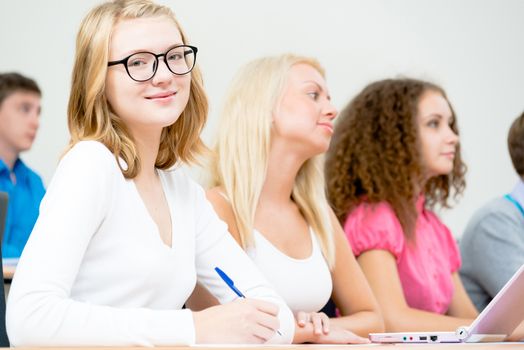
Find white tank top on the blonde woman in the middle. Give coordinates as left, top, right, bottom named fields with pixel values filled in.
left=247, top=229, right=333, bottom=312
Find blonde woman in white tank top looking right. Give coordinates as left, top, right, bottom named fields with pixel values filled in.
left=207, top=55, right=383, bottom=343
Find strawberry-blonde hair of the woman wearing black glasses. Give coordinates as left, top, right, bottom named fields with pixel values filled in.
left=67, top=0, right=208, bottom=178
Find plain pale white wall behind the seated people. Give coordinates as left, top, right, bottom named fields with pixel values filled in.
left=0, top=0, right=524, bottom=237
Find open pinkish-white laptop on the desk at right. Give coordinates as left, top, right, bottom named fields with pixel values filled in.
left=369, top=265, right=524, bottom=343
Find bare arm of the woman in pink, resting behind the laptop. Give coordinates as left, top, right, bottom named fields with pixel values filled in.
left=358, top=250, right=474, bottom=332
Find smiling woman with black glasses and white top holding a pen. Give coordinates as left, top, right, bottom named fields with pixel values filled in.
left=7, top=0, right=294, bottom=346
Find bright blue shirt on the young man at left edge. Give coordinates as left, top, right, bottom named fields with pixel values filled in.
left=0, top=159, right=45, bottom=258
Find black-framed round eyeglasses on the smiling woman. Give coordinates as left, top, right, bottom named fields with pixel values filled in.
left=107, top=45, right=198, bottom=82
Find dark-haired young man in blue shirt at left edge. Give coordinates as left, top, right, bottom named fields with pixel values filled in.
left=0, top=73, right=45, bottom=258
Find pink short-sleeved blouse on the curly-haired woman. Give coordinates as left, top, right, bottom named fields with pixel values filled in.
left=344, top=196, right=460, bottom=314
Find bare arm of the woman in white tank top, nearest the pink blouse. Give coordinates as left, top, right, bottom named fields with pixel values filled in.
left=330, top=210, right=384, bottom=337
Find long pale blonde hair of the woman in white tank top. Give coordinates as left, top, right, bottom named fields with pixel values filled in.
left=211, top=54, right=335, bottom=267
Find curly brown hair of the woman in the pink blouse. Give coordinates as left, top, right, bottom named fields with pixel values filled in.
left=325, top=79, right=466, bottom=239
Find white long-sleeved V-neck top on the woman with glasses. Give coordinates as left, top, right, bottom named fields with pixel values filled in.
left=6, top=141, right=294, bottom=346
